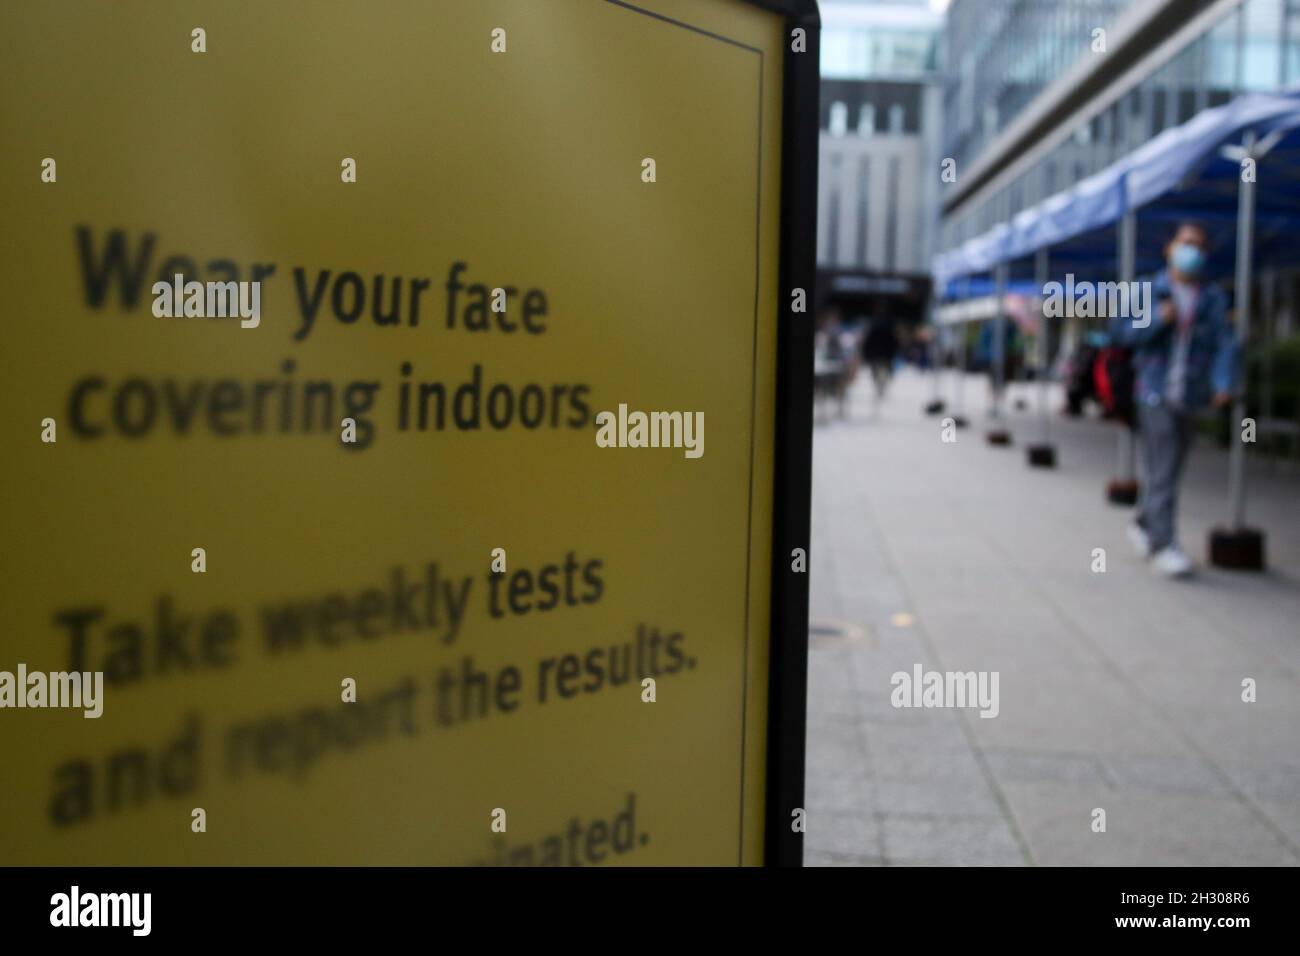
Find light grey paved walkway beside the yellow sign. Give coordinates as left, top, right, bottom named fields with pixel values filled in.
left=805, top=372, right=1300, bottom=866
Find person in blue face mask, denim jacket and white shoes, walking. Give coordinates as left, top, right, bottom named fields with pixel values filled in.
left=1112, top=222, right=1236, bottom=578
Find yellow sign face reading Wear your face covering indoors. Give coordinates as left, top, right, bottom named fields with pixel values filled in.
left=0, top=0, right=784, bottom=865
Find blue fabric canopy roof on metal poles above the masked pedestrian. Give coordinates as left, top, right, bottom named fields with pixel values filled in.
left=933, top=90, right=1300, bottom=298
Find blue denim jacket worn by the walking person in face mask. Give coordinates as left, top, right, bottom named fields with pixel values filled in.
left=1110, top=269, right=1238, bottom=411
